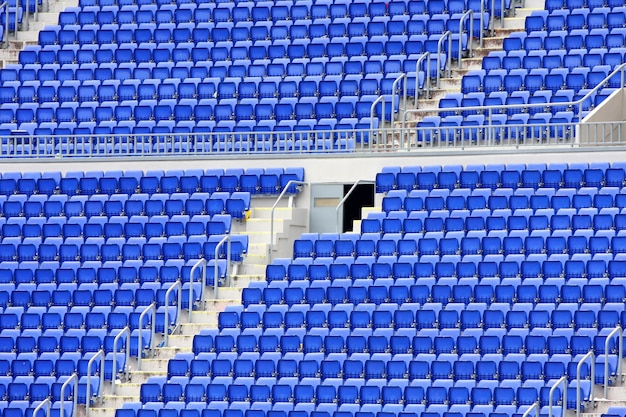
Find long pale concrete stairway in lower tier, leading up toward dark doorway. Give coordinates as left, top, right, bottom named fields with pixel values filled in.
left=86, top=197, right=308, bottom=417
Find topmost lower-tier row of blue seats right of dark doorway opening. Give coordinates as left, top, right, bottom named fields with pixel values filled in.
left=376, top=167, right=626, bottom=192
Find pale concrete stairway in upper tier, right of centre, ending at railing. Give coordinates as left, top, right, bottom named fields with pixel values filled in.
left=394, top=0, right=545, bottom=127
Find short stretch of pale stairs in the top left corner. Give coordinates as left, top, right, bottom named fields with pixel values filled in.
left=0, top=0, right=78, bottom=68
